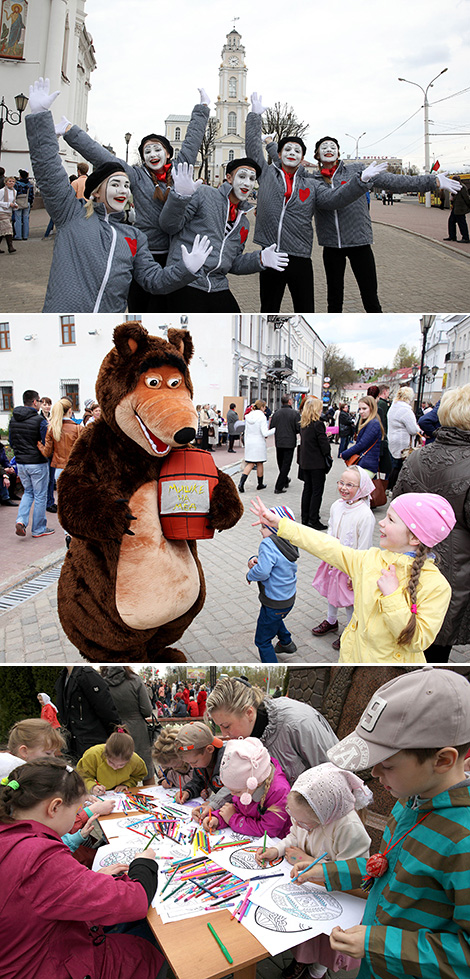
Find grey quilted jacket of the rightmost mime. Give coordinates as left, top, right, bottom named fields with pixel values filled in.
left=310, top=159, right=436, bottom=248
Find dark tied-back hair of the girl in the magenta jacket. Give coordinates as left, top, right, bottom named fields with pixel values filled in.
left=0, top=758, right=86, bottom=823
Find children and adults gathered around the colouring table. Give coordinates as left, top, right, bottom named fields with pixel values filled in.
left=0, top=667, right=470, bottom=979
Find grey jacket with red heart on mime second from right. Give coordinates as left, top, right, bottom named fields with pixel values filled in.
left=245, top=112, right=371, bottom=258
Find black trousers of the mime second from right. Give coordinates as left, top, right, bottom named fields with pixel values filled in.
left=259, top=255, right=315, bottom=313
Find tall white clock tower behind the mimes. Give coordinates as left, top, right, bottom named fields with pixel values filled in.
left=211, top=27, right=249, bottom=184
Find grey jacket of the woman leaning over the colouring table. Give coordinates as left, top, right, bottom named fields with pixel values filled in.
left=207, top=697, right=338, bottom=809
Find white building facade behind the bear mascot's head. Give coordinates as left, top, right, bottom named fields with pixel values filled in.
left=0, top=313, right=326, bottom=431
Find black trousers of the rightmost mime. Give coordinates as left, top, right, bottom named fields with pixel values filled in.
left=323, top=245, right=382, bottom=313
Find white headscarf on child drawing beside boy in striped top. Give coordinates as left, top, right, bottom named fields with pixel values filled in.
left=292, top=762, right=373, bottom=826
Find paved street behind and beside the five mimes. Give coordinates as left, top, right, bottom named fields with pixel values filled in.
left=2, top=198, right=470, bottom=315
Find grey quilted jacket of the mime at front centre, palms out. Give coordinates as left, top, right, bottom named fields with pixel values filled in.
left=160, top=181, right=262, bottom=292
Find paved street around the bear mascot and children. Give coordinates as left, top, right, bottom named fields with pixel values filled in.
left=0, top=444, right=470, bottom=665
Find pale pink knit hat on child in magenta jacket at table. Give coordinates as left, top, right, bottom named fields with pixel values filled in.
left=220, top=738, right=271, bottom=806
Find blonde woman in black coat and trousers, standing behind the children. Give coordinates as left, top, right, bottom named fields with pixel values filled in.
left=299, top=398, right=331, bottom=530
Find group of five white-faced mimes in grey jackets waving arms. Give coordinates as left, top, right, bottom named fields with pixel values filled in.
left=5, top=78, right=461, bottom=313
